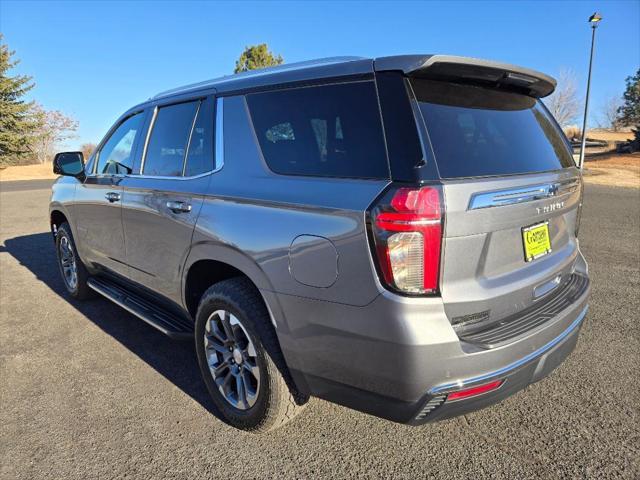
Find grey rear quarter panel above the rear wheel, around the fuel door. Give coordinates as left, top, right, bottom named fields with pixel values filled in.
left=188, top=97, right=387, bottom=305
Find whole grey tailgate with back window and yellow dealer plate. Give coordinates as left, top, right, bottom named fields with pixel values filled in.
left=411, top=79, right=581, bottom=325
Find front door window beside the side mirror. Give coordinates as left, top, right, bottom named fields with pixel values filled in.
left=96, top=113, right=142, bottom=174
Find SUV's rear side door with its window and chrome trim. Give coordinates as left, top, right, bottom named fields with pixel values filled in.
left=122, top=98, right=214, bottom=303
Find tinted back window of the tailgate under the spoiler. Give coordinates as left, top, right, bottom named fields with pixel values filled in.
left=412, top=80, right=575, bottom=178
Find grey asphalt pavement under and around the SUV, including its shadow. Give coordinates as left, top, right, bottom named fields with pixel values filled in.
left=0, top=179, right=640, bottom=479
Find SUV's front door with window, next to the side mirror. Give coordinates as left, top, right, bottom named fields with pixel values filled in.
left=74, top=112, right=144, bottom=277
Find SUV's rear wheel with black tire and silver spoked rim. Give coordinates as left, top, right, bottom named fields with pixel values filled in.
left=195, top=278, right=308, bottom=433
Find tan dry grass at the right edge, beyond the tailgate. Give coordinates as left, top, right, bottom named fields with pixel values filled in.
left=584, top=152, right=640, bottom=188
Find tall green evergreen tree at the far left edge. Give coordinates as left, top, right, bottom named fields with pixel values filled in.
left=0, top=34, right=38, bottom=165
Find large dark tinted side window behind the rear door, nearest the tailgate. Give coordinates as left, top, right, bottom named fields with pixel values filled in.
left=247, top=82, right=389, bottom=178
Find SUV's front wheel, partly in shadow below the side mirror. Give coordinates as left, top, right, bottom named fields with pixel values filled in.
left=56, top=222, right=93, bottom=300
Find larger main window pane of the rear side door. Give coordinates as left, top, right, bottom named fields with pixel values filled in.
left=143, top=102, right=199, bottom=177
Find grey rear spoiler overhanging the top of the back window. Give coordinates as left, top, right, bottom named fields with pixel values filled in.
left=374, top=55, right=556, bottom=98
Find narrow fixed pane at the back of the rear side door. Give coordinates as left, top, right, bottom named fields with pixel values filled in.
left=184, top=99, right=213, bottom=177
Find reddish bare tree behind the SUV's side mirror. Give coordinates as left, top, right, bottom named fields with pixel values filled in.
left=31, top=104, right=78, bottom=163
